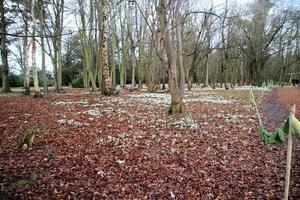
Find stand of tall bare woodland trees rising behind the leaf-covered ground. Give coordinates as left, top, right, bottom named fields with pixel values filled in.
left=0, top=0, right=300, bottom=113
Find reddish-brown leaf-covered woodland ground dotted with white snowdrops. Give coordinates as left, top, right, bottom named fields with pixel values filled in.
left=0, top=88, right=300, bottom=200
